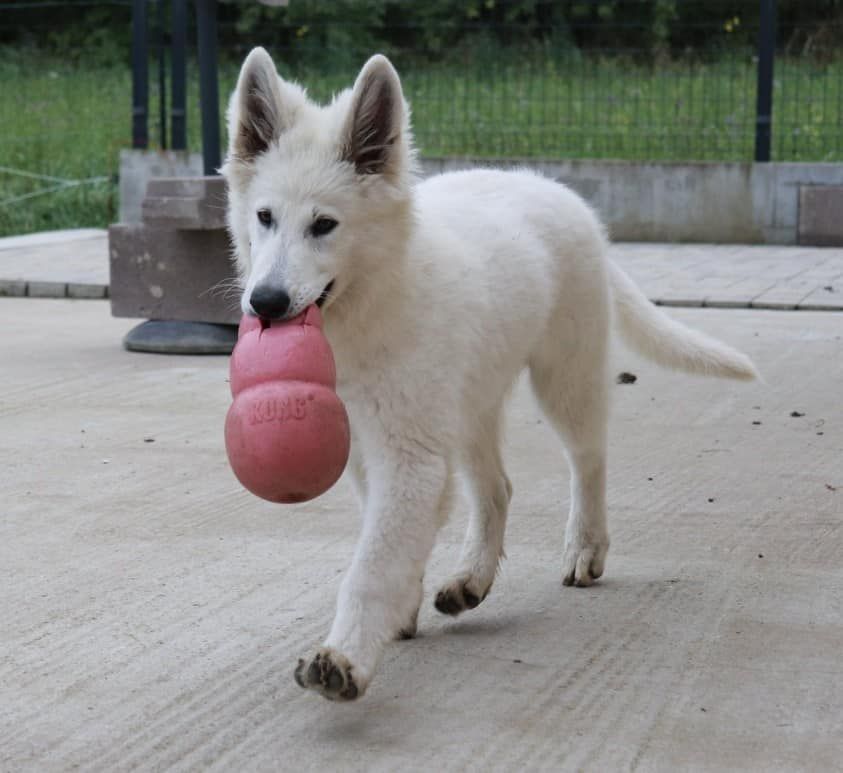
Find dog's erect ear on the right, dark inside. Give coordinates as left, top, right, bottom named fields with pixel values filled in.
left=343, top=54, right=404, bottom=175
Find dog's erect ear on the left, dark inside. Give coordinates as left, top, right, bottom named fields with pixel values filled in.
left=228, top=48, right=290, bottom=163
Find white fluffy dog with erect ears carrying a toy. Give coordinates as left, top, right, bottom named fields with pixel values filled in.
left=223, top=48, right=756, bottom=700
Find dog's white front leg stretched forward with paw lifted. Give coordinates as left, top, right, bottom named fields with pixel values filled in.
left=295, top=449, right=450, bottom=700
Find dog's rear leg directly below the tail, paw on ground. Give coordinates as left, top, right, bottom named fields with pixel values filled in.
left=530, top=322, right=609, bottom=587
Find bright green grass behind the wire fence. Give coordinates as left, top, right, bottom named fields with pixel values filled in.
left=0, top=49, right=843, bottom=235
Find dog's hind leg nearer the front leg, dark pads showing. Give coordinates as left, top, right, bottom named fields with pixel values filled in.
left=435, top=406, right=512, bottom=615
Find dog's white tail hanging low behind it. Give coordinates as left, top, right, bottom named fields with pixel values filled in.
left=609, top=261, right=759, bottom=381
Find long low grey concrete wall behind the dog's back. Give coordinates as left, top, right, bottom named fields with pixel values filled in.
left=422, top=158, right=843, bottom=244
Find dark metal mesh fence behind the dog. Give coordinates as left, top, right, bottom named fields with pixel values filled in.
left=0, top=0, right=843, bottom=233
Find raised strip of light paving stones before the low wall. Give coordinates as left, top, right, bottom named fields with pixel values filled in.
left=0, top=229, right=843, bottom=310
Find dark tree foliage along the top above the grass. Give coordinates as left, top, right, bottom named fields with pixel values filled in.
left=0, top=0, right=843, bottom=66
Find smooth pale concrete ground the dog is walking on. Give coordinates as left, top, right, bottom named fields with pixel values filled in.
left=0, top=294, right=843, bottom=773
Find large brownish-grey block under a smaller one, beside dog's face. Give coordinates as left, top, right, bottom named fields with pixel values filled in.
left=108, top=224, right=240, bottom=324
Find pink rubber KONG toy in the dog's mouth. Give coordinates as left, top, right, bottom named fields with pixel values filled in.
left=225, top=306, right=350, bottom=503
